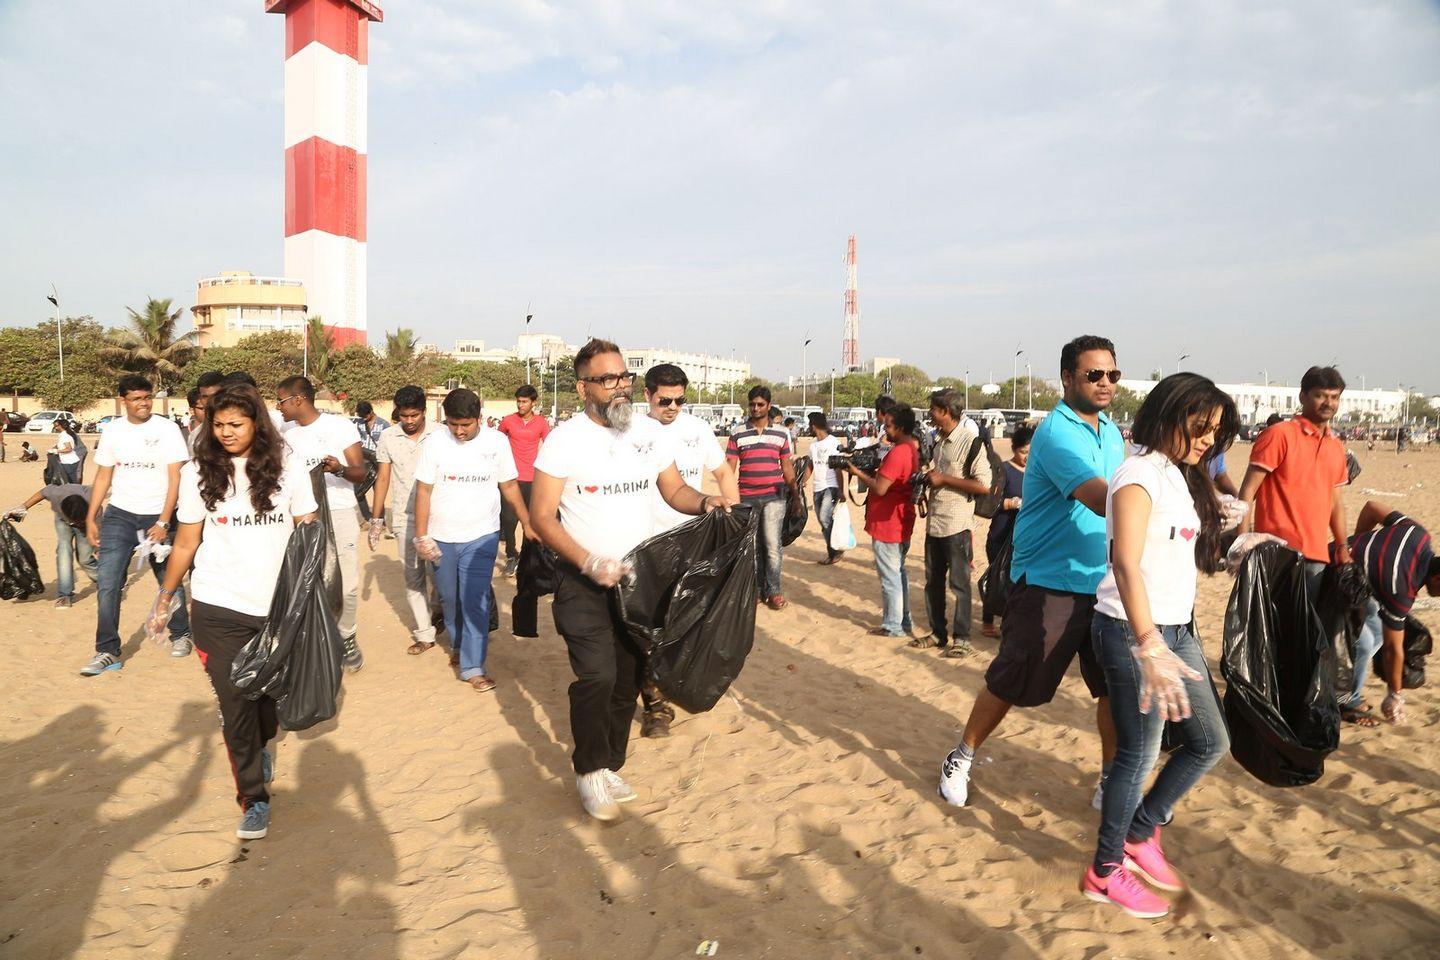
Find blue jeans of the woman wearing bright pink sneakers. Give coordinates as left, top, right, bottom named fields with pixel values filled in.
left=1090, top=612, right=1230, bottom=869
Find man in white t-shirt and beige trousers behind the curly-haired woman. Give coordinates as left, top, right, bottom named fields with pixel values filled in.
left=275, top=377, right=367, bottom=674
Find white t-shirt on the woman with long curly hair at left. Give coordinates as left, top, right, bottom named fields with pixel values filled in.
left=176, top=452, right=318, bottom=616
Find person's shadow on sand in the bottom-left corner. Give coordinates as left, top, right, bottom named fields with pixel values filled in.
left=0, top=702, right=213, bottom=957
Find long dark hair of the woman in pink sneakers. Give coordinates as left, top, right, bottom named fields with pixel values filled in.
left=1132, top=373, right=1240, bottom=573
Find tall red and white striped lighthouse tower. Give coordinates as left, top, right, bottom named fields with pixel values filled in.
left=265, top=0, right=384, bottom=347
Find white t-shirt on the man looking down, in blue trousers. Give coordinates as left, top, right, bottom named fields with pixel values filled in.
left=415, top=427, right=518, bottom=544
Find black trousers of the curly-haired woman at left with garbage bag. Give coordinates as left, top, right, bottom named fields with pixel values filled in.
left=190, top=600, right=279, bottom=809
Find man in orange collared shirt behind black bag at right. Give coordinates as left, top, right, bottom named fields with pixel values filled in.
left=1240, top=367, right=1351, bottom=581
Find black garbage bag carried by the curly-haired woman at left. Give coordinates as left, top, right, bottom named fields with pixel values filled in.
left=230, top=466, right=344, bottom=730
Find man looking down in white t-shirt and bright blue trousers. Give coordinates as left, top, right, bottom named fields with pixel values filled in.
left=415, top=387, right=533, bottom=694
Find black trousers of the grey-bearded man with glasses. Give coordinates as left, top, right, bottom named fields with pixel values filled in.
left=552, top=564, right=644, bottom=774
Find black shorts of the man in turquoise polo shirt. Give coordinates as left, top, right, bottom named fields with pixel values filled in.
left=985, top=579, right=1106, bottom=707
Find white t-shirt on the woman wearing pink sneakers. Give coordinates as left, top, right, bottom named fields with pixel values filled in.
left=1094, top=452, right=1200, bottom=626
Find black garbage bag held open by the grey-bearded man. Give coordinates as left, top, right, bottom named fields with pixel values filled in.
left=616, top=504, right=760, bottom=714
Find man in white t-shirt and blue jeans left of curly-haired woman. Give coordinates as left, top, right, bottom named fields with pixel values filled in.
left=81, top=374, right=192, bottom=676
